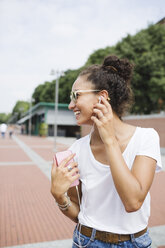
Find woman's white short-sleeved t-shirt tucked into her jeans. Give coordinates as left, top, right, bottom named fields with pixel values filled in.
left=69, top=127, right=162, bottom=234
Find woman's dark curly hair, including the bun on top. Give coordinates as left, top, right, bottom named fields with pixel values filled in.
left=79, top=55, right=133, bottom=118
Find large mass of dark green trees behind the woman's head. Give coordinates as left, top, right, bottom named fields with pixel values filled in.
left=33, top=24, right=165, bottom=114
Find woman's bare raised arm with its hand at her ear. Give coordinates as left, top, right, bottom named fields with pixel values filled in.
left=91, top=97, right=156, bottom=212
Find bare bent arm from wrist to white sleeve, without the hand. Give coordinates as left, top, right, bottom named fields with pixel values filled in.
left=106, top=142, right=156, bottom=212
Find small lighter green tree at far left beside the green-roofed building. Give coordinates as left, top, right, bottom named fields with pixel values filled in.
left=12, top=101, right=30, bottom=120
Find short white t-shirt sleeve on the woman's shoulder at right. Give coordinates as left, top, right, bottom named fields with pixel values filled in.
left=137, top=128, right=162, bottom=172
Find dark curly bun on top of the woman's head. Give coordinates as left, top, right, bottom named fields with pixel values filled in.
left=102, top=55, right=133, bottom=83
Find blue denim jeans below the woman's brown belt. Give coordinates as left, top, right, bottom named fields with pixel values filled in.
left=72, top=228, right=152, bottom=248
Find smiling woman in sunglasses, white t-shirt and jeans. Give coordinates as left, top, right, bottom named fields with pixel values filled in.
left=51, top=56, right=161, bottom=248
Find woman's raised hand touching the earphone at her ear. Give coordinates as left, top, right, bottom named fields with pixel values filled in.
left=91, top=97, right=116, bottom=144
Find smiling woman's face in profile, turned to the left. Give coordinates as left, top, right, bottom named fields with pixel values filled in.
left=69, top=76, right=99, bottom=125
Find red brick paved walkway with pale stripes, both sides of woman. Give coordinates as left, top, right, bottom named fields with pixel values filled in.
left=0, top=136, right=165, bottom=248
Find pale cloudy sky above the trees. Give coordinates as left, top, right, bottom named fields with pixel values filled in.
left=0, top=0, right=165, bottom=113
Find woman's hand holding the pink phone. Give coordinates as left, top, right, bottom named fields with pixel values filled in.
left=51, top=154, right=80, bottom=200
